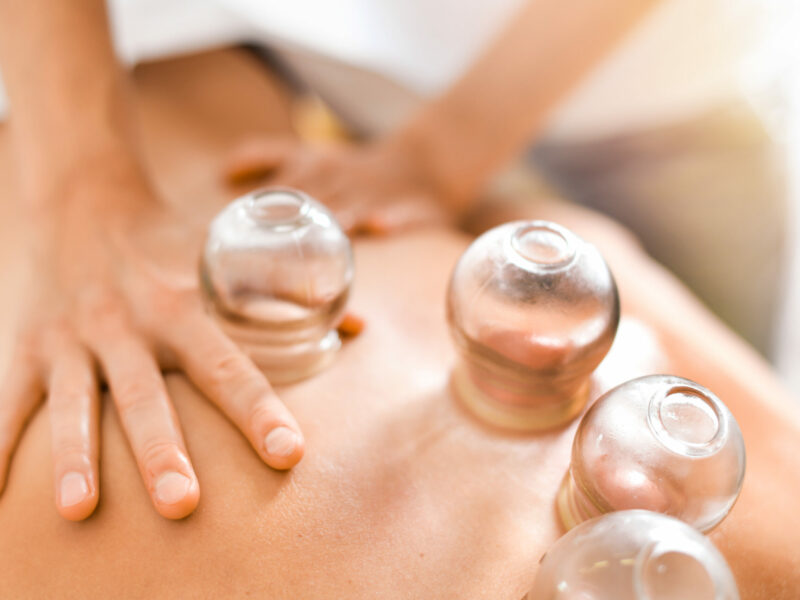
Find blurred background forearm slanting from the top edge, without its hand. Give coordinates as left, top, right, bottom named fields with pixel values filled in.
left=397, top=0, right=657, bottom=207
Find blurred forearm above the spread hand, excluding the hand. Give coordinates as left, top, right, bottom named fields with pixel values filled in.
left=0, top=0, right=141, bottom=202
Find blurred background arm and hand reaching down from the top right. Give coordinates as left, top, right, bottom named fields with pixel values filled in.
left=222, top=0, right=658, bottom=229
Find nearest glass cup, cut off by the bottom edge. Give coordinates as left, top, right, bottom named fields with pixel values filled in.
left=526, top=510, right=739, bottom=600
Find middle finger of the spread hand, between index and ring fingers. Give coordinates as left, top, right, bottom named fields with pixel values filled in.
left=97, top=328, right=200, bottom=519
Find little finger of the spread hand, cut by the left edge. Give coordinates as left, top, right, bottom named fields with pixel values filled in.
left=0, top=348, right=43, bottom=492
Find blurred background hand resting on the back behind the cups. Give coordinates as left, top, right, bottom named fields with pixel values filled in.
left=225, top=138, right=457, bottom=234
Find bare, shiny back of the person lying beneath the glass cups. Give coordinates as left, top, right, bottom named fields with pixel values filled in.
left=0, top=48, right=800, bottom=600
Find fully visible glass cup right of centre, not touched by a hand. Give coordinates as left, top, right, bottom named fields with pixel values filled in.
left=447, top=221, right=619, bottom=431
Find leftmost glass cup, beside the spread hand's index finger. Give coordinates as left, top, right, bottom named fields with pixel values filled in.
left=200, top=188, right=353, bottom=383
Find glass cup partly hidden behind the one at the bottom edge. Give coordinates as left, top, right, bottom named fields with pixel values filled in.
left=557, top=375, right=745, bottom=531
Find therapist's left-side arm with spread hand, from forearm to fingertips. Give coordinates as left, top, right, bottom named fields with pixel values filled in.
left=0, top=0, right=304, bottom=519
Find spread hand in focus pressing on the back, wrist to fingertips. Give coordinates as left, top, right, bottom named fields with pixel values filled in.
left=0, top=161, right=304, bottom=520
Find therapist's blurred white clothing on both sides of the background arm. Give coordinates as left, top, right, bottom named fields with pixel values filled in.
left=0, top=0, right=764, bottom=139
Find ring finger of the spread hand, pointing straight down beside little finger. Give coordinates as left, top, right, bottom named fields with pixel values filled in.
left=47, top=344, right=99, bottom=521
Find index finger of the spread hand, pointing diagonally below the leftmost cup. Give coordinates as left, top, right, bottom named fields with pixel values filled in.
left=165, top=310, right=304, bottom=469
